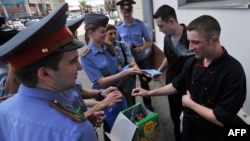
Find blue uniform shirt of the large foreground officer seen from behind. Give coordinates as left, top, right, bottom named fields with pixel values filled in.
left=0, top=85, right=98, bottom=141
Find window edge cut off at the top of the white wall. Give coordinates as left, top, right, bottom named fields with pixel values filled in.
left=178, top=0, right=250, bottom=9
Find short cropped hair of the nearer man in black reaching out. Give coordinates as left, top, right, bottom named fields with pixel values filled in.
left=187, top=15, right=221, bottom=41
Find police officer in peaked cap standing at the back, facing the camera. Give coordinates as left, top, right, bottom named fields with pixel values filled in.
left=116, top=0, right=153, bottom=111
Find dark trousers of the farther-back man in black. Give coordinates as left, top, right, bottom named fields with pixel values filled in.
left=168, top=93, right=183, bottom=141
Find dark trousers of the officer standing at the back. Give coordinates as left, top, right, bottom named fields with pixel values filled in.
left=134, top=59, right=152, bottom=107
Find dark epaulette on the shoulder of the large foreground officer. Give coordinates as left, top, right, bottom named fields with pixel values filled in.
left=50, top=100, right=86, bottom=122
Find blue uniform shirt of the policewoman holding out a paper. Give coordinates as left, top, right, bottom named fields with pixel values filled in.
left=81, top=43, right=118, bottom=89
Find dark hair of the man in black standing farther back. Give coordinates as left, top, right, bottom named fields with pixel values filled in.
left=153, top=5, right=178, bottom=22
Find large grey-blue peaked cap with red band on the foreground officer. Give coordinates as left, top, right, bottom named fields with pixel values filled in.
left=0, top=3, right=84, bottom=69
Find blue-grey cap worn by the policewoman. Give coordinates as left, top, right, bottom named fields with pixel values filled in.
left=84, top=14, right=109, bottom=27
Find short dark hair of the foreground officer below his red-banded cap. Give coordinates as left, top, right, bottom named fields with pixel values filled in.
left=15, top=52, right=64, bottom=87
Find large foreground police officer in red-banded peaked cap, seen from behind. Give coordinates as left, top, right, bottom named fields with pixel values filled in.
left=0, top=3, right=98, bottom=141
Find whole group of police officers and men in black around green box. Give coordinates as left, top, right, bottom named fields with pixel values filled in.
left=0, top=0, right=246, bottom=141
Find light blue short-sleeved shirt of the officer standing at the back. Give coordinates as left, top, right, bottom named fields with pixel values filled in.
left=116, top=19, right=152, bottom=60
